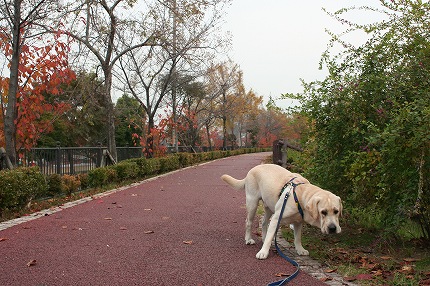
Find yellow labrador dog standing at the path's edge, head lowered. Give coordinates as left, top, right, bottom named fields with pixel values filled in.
left=221, top=164, right=342, bottom=259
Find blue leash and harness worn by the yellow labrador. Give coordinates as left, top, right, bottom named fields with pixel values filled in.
left=267, top=178, right=303, bottom=286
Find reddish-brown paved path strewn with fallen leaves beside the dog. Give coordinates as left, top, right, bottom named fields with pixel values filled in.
left=0, top=153, right=325, bottom=286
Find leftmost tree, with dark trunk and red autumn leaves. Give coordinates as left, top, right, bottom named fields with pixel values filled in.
left=0, top=0, right=67, bottom=165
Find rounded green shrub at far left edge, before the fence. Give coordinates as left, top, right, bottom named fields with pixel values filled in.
left=0, top=167, right=48, bottom=213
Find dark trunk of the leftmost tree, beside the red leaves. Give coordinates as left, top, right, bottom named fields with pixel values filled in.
left=4, top=0, right=21, bottom=166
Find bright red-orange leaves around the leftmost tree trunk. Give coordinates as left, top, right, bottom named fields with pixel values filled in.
left=0, top=31, right=76, bottom=149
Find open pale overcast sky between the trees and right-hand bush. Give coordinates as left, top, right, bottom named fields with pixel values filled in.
left=225, top=0, right=381, bottom=107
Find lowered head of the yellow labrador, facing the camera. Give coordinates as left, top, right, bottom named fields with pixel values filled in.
left=306, top=191, right=342, bottom=234
